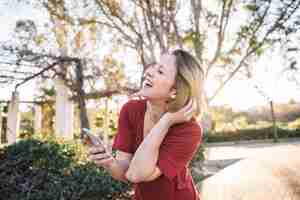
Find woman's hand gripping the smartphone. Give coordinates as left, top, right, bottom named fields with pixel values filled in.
left=88, top=145, right=115, bottom=168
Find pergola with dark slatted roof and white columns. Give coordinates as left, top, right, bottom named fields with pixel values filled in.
left=0, top=45, right=85, bottom=144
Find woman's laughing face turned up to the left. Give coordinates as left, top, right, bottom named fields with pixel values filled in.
left=140, top=54, right=177, bottom=100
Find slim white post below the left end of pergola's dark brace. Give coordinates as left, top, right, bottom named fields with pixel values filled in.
left=7, top=92, right=20, bottom=145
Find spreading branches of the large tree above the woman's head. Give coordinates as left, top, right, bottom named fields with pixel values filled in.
left=88, top=0, right=300, bottom=100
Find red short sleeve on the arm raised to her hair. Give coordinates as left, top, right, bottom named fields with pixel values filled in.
left=157, top=123, right=202, bottom=180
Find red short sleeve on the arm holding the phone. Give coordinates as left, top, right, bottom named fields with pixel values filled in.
left=112, top=102, right=134, bottom=153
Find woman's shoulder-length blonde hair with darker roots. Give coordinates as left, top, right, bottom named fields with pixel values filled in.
left=168, top=49, right=205, bottom=116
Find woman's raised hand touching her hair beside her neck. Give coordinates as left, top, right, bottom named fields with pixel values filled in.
left=163, top=99, right=195, bottom=126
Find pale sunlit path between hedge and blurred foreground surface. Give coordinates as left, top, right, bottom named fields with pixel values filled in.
left=196, top=138, right=300, bottom=177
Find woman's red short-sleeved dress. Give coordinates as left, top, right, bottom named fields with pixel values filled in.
left=113, top=100, right=202, bottom=200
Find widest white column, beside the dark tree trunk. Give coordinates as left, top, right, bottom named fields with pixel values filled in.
left=55, top=79, right=74, bottom=139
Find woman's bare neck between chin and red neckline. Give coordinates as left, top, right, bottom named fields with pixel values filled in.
left=147, top=101, right=166, bottom=122
